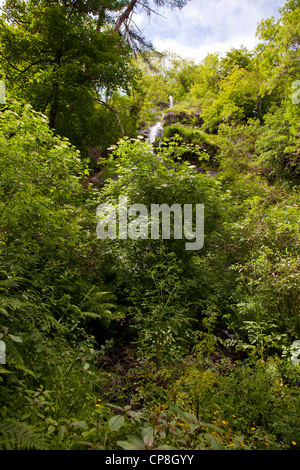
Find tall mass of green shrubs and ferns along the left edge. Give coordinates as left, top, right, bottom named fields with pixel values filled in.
left=0, top=98, right=123, bottom=449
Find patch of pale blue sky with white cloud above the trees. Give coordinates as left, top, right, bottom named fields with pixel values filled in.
left=133, top=0, right=286, bottom=62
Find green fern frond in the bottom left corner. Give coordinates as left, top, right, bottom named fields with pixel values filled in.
left=0, top=419, right=49, bottom=450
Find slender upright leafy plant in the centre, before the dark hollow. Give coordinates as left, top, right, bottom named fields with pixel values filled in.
left=132, top=255, right=192, bottom=368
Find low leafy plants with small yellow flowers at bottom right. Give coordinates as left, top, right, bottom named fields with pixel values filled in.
left=98, top=359, right=299, bottom=450
